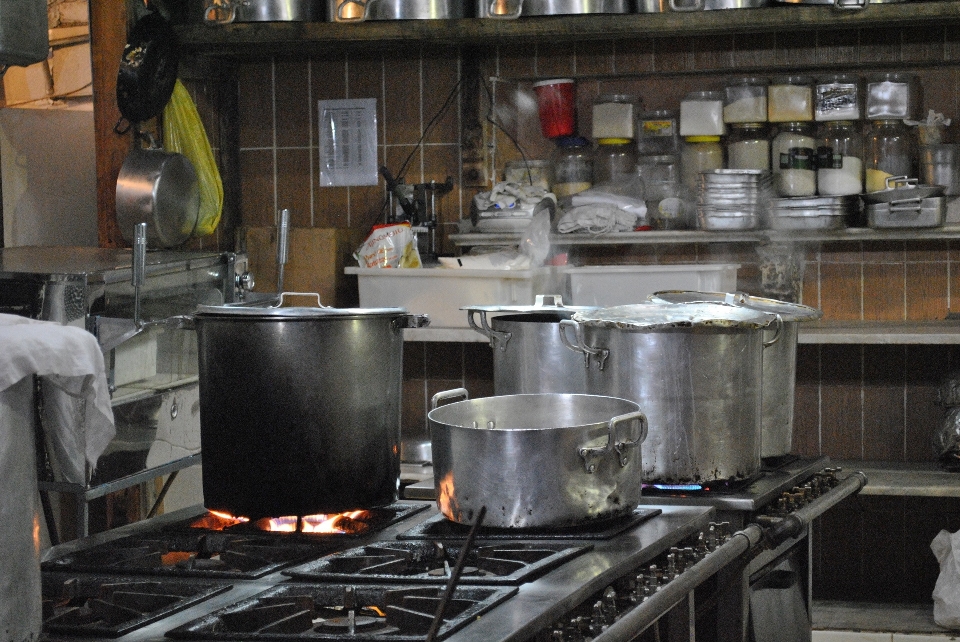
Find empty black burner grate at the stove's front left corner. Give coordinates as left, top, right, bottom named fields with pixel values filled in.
left=43, top=573, right=231, bottom=638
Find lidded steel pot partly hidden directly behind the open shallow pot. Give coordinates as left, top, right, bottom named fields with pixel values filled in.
left=463, top=295, right=590, bottom=395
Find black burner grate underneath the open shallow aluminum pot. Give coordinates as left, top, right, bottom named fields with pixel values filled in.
left=397, top=508, right=662, bottom=541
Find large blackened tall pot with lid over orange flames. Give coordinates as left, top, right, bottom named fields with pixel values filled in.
left=183, top=298, right=427, bottom=518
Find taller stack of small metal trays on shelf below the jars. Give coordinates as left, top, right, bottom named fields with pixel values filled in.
left=697, top=169, right=772, bottom=231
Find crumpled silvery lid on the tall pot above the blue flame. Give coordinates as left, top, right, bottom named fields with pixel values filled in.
left=573, top=302, right=777, bottom=330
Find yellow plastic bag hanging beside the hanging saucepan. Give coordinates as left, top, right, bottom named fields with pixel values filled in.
left=163, top=80, right=223, bottom=236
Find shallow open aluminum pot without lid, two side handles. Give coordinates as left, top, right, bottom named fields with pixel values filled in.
left=427, top=388, right=647, bottom=528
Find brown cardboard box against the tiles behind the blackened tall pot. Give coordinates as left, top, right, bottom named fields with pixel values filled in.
left=242, top=227, right=363, bottom=308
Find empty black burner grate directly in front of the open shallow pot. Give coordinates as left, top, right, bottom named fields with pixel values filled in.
left=283, top=541, right=593, bottom=584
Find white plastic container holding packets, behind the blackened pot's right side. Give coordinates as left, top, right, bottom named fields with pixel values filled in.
left=344, top=267, right=563, bottom=329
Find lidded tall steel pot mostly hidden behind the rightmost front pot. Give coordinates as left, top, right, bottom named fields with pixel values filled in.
left=650, top=291, right=823, bottom=458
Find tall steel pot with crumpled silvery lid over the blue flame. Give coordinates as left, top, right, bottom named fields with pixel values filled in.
left=560, top=303, right=777, bottom=484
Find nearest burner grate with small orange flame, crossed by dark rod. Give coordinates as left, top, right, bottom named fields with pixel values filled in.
left=166, top=583, right=517, bottom=642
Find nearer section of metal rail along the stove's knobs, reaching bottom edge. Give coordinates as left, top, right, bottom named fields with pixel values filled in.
left=593, top=524, right=763, bottom=642
